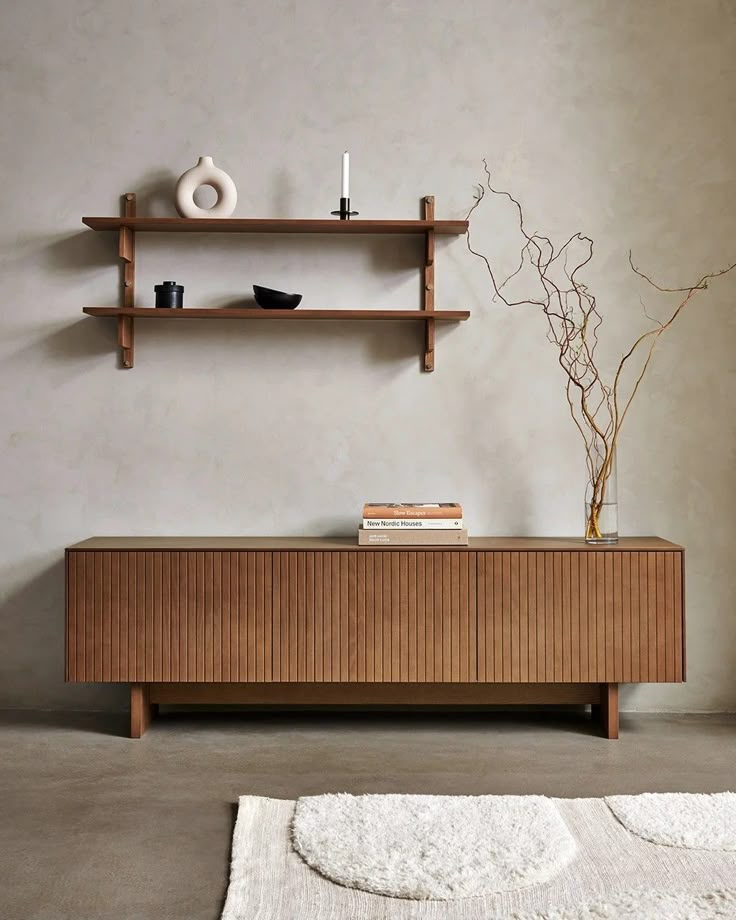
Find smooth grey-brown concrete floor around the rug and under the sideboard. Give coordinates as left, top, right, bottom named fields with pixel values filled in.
left=0, top=712, right=736, bottom=920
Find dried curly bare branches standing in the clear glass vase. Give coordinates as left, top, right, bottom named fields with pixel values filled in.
left=466, top=160, right=736, bottom=539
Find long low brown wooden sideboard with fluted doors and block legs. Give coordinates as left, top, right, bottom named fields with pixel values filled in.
left=66, top=537, right=685, bottom=738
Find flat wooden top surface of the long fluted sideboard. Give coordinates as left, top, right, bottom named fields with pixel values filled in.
left=67, top=536, right=683, bottom=553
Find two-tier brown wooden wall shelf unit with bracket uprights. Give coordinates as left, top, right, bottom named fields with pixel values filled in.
left=82, top=192, right=470, bottom=371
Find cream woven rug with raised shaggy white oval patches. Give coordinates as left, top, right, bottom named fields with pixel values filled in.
left=222, top=795, right=736, bottom=920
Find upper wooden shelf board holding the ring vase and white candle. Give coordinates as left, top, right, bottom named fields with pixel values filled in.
left=82, top=217, right=468, bottom=236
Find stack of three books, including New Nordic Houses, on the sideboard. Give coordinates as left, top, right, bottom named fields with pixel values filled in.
left=358, top=502, right=468, bottom=546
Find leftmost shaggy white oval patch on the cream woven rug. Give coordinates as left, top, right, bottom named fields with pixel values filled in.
left=292, top=794, right=576, bottom=900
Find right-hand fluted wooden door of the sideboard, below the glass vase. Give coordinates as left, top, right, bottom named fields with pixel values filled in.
left=477, top=551, right=684, bottom=683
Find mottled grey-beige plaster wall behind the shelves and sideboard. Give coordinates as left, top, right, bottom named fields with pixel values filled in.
left=0, top=0, right=736, bottom=710
